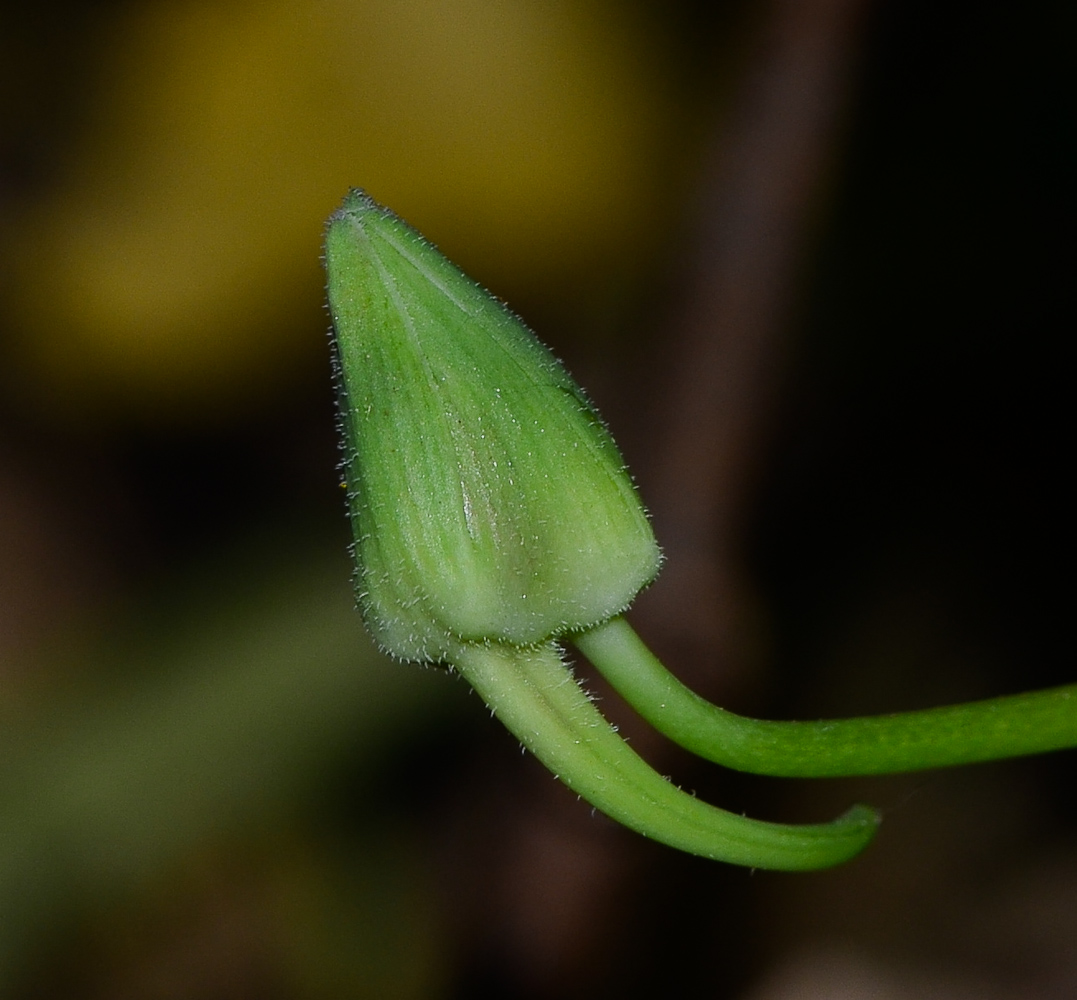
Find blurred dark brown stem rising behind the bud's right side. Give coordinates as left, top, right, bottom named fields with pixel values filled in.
left=637, top=0, right=866, bottom=688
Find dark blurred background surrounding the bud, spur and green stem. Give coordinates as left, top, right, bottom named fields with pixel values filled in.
left=0, top=0, right=1077, bottom=1000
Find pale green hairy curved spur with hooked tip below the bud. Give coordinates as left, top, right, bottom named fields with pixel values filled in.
left=452, top=643, right=877, bottom=871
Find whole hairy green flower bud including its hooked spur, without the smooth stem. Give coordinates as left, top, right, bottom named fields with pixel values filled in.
left=325, top=191, right=876, bottom=870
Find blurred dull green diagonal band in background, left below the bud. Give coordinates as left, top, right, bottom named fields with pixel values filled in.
left=0, top=549, right=462, bottom=996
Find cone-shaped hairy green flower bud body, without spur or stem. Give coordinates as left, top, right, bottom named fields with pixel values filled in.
left=325, top=191, right=660, bottom=661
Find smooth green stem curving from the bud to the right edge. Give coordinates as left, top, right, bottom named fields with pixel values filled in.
left=573, top=617, right=1077, bottom=777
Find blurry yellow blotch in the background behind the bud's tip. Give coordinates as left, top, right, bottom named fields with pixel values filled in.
left=2, top=0, right=660, bottom=410
